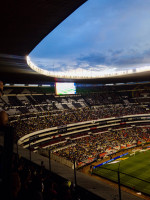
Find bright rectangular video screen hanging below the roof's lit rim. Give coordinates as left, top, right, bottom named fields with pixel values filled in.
left=55, top=82, right=76, bottom=95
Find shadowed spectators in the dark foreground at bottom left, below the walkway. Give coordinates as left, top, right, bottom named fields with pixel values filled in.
left=9, top=155, right=82, bottom=200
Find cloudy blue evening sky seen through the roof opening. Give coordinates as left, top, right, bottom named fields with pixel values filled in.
left=29, top=0, right=150, bottom=76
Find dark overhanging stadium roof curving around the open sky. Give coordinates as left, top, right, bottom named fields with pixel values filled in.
left=0, top=0, right=150, bottom=84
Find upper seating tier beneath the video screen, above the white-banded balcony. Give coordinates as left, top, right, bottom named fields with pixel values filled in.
left=1, top=84, right=150, bottom=145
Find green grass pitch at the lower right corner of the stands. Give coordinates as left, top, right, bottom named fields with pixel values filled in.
left=93, top=150, right=150, bottom=195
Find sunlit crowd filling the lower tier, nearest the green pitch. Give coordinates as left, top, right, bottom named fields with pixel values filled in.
left=55, top=127, right=150, bottom=165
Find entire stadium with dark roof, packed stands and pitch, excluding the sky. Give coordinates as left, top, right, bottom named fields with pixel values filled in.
left=0, top=0, right=150, bottom=200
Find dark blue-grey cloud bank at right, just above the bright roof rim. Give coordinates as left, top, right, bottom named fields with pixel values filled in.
left=77, top=49, right=150, bottom=70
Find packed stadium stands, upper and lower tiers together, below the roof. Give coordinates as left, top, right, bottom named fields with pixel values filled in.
left=0, top=83, right=150, bottom=198
